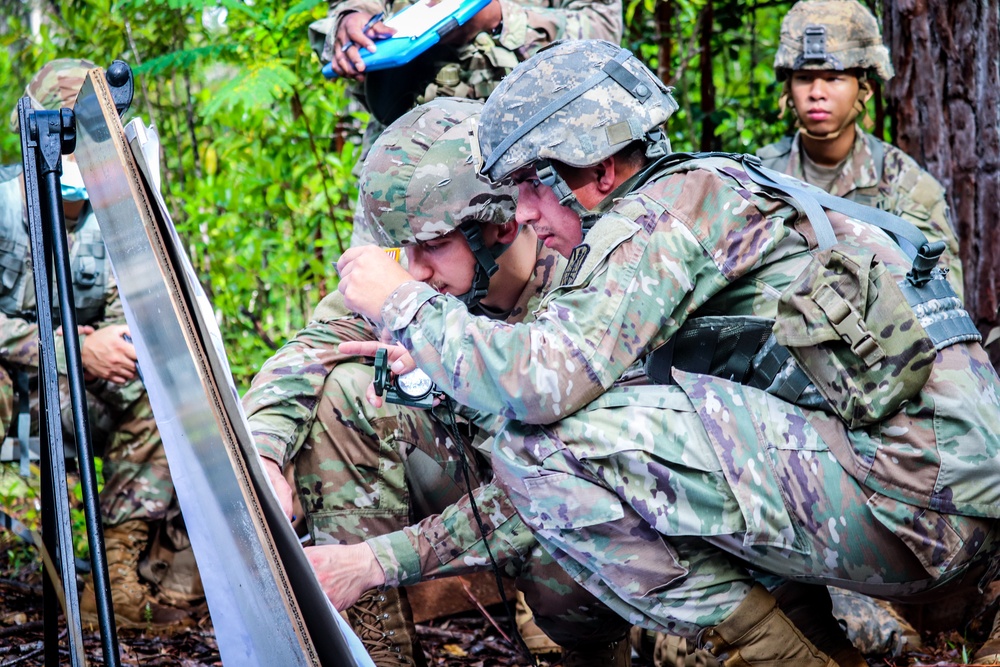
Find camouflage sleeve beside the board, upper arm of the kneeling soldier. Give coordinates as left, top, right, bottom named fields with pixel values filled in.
left=243, top=293, right=375, bottom=465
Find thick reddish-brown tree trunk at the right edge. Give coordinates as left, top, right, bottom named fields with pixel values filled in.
left=883, top=0, right=1000, bottom=365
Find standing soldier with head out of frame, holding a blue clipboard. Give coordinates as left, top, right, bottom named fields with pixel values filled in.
left=310, top=0, right=622, bottom=246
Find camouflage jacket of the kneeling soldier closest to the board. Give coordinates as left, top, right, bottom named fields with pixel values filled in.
left=243, top=239, right=565, bottom=585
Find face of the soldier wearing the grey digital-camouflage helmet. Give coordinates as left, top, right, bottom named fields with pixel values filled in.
left=514, top=169, right=583, bottom=257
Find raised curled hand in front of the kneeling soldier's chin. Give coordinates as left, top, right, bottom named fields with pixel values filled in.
left=337, top=246, right=413, bottom=324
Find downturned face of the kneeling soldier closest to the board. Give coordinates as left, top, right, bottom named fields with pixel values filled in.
left=406, top=225, right=486, bottom=295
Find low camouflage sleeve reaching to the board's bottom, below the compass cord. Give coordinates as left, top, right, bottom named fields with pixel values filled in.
left=367, top=483, right=535, bottom=587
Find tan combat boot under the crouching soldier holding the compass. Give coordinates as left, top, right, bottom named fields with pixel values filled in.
left=701, top=585, right=839, bottom=667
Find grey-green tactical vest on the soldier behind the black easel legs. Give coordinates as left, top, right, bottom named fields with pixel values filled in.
left=0, top=165, right=108, bottom=324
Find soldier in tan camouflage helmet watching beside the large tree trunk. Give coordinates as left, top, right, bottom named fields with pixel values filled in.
left=757, top=0, right=963, bottom=296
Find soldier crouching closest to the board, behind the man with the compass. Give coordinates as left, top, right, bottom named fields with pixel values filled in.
left=243, top=98, right=629, bottom=666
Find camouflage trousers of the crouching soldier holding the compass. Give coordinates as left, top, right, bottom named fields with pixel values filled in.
left=493, top=379, right=1000, bottom=638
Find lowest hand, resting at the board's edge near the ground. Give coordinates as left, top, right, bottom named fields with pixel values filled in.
left=305, top=542, right=385, bottom=611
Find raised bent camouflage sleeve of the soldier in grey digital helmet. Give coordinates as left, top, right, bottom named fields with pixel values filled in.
left=382, top=170, right=787, bottom=424
